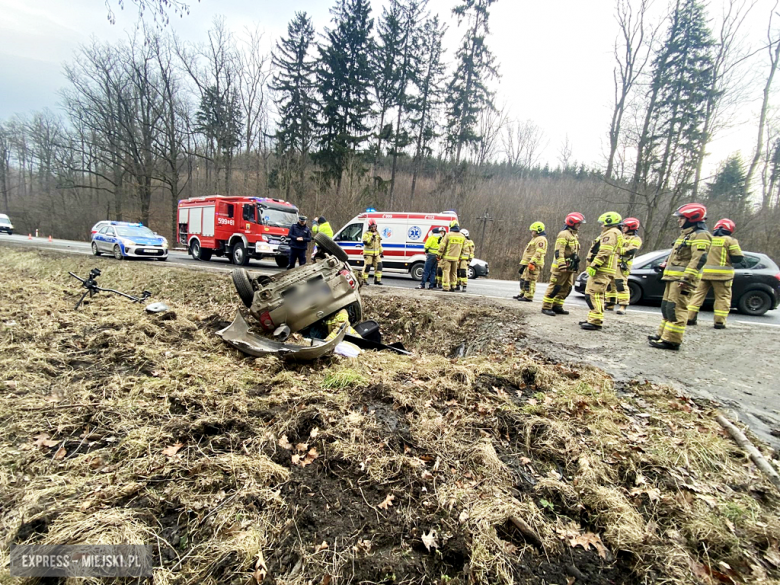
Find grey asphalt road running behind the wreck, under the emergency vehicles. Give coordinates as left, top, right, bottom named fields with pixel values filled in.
left=0, top=234, right=780, bottom=327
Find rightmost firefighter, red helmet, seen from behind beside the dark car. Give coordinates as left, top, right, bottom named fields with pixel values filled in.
left=688, top=219, right=744, bottom=329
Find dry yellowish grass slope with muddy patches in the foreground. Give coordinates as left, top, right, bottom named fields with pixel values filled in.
left=0, top=248, right=780, bottom=585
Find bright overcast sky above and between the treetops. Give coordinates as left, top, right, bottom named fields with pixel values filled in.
left=0, top=0, right=774, bottom=169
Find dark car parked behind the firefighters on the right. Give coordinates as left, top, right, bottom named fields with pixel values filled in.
left=574, top=250, right=780, bottom=315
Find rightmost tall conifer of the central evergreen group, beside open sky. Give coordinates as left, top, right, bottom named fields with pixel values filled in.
left=447, top=0, right=498, bottom=164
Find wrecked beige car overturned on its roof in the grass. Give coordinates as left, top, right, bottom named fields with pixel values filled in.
left=218, top=233, right=408, bottom=361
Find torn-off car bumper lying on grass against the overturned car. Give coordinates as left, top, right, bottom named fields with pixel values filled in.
left=217, top=311, right=347, bottom=362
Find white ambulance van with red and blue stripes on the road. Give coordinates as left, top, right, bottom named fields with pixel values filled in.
left=333, top=210, right=458, bottom=280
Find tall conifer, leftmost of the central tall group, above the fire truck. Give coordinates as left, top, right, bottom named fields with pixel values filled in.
left=271, top=12, right=316, bottom=199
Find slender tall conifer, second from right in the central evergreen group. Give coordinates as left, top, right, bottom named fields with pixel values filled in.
left=410, top=16, right=446, bottom=200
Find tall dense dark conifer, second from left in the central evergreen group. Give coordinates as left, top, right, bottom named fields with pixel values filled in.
left=316, top=0, right=373, bottom=193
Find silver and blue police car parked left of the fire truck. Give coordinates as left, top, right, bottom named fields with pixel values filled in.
left=92, top=221, right=168, bottom=260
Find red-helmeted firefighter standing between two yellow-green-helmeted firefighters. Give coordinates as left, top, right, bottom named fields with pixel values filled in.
left=542, top=213, right=585, bottom=317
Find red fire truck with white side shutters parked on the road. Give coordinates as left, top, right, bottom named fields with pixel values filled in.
left=178, top=195, right=298, bottom=266
